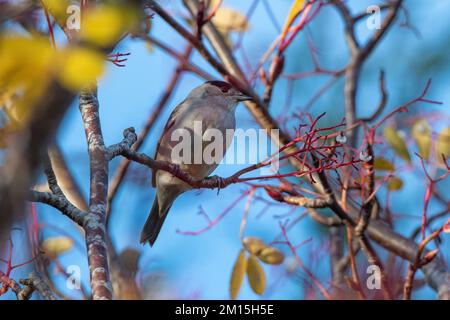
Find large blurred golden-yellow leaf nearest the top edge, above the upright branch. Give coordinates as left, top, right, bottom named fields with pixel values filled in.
left=81, top=5, right=138, bottom=47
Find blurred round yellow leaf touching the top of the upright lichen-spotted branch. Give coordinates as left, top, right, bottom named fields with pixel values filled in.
left=58, top=48, right=104, bottom=91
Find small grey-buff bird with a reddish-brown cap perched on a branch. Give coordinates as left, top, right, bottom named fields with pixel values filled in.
left=141, top=81, right=251, bottom=246
